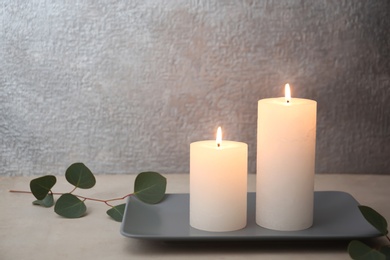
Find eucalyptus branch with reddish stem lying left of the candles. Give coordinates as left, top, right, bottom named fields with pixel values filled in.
left=10, top=163, right=167, bottom=222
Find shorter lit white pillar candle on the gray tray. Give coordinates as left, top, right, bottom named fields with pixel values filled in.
left=190, top=128, right=248, bottom=232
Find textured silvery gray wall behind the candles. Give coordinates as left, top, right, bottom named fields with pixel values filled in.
left=0, top=0, right=390, bottom=175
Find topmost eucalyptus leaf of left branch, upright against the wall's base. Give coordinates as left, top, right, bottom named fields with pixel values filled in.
left=65, top=163, right=96, bottom=189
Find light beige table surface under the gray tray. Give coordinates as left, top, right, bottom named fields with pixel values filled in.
left=0, top=174, right=390, bottom=260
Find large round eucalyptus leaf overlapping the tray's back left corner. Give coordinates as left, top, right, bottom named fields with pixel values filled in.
left=134, top=172, right=167, bottom=204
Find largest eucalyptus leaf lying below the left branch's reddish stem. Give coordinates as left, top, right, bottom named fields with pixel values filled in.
left=54, top=193, right=87, bottom=218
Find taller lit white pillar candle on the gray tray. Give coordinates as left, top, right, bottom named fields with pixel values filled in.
left=256, top=86, right=317, bottom=231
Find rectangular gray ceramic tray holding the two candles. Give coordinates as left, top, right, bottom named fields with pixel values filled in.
left=121, top=191, right=381, bottom=241
